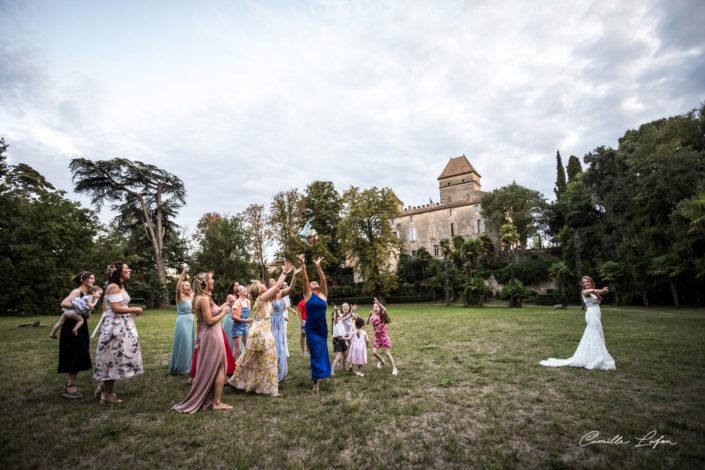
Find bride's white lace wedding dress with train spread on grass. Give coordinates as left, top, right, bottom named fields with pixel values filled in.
left=539, top=296, right=617, bottom=370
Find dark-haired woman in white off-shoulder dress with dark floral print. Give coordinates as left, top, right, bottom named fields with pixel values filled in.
left=93, top=262, right=144, bottom=403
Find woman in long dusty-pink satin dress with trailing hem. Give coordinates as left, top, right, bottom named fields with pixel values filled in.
left=172, top=273, right=232, bottom=413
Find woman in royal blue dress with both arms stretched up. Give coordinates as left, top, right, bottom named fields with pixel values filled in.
left=298, top=255, right=330, bottom=393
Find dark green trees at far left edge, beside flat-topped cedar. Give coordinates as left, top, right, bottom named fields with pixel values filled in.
left=0, top=145, right=100, bottom=315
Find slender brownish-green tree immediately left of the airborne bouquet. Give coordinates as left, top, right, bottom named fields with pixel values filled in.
left=269, top=189, right=304, bottom=259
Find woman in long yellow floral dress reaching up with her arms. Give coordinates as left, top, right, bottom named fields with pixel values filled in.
left=228, top=261, right=294, bottom=397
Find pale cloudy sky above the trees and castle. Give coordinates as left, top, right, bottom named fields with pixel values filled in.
left=0, top=0, right=705, bottom=234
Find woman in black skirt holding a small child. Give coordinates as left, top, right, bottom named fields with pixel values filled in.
left=58, top=271, right=95, bottom=398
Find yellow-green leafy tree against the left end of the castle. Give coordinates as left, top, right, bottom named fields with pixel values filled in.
left=338, top=186, right=401, bottom=298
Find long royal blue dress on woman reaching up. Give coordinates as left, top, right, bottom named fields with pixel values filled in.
left=305, top=294, right=331, bottom=382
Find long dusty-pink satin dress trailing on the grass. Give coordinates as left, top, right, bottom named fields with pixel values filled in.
left=172, top=305, right=226, bottom=413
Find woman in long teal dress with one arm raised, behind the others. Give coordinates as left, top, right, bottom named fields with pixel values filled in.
left=169, top=265, right=196, bottom=375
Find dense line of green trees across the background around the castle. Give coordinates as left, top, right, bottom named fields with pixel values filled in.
left=0, top=105, right=705, bottom=314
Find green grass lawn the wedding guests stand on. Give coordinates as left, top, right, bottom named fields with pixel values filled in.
left=0, top=305, right=705, bottom=469
